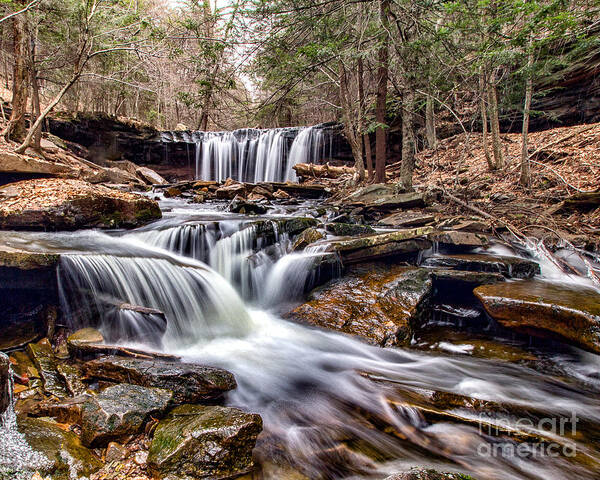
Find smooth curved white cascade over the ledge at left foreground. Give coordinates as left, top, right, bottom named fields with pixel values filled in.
left=59, top=255, right=251, bottom=345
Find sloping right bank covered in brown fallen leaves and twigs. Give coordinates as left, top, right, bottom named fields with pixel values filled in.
left=331, top=123, right=600, bottom=251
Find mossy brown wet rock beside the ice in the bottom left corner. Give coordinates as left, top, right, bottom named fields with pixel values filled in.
left=17, top=416, right=102, bottom=480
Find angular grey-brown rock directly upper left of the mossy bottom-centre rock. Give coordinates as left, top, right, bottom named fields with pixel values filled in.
left=81, top=383, right=173, bottom=447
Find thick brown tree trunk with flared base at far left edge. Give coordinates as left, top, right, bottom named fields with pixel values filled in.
left=2, top=13, right=29, bottom=141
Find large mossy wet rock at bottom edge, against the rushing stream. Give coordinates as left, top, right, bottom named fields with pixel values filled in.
left=148, top=405, right=262, bottom=480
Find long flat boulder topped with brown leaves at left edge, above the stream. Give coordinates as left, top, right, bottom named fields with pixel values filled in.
left=0, top=179, right=161, bottom=230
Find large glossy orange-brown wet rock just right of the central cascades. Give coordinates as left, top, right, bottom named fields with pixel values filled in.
left=289, top=266, right=432, bottom=345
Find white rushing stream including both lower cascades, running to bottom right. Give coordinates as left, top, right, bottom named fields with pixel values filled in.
left=0, top=197, right=600, bottom=480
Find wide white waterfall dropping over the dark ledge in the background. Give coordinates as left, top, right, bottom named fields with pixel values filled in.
left=162, top=125, right=335, bottom=183
